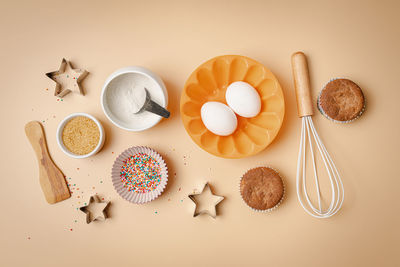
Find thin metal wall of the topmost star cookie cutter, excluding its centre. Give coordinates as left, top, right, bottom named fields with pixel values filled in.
left=46, top=58, right=89, bottom=98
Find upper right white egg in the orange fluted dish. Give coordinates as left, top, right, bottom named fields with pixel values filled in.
left=225, top=82, right=261, bottom=118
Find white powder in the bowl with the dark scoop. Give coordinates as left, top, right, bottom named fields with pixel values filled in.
left=105, top=72, right=164, bottom=129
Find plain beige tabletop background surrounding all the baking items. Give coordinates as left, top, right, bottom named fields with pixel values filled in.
left=0, top=1, right=400, bottom=266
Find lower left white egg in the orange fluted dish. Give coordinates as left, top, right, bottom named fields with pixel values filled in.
left=201, top=102, right=237, bottom=136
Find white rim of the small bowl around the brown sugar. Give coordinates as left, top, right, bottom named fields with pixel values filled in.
left=57, top=112, right=105, bottom=159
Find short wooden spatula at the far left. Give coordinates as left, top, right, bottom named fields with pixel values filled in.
left=25, top=121, right=71, bottom=204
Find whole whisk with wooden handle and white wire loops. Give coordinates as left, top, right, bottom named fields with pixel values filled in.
left=292, top=52, right=344, bottom=218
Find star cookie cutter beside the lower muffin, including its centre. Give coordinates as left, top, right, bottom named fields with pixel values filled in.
left=188, top=183, right=224, bottom=219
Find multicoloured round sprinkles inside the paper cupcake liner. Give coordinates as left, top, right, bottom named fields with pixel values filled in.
left=120, top=153, right=161, bottom=193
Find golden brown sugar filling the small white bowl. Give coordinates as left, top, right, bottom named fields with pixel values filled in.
left=62, top=116, right=100, bottom=155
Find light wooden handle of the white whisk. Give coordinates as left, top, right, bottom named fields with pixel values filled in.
left=292, top=52, right=314, bottom=117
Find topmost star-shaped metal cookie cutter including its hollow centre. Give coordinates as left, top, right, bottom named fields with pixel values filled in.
left=46, top=58, right=89, bottom=98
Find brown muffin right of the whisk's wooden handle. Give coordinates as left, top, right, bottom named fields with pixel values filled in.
left=317, top=79, right=365, bottom=123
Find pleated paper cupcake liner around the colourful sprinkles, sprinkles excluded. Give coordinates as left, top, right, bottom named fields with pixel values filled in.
left=111, top=146, right=168, bottom=204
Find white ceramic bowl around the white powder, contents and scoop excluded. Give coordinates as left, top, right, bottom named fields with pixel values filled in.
left=100, top=66, right=168, bottom=132
